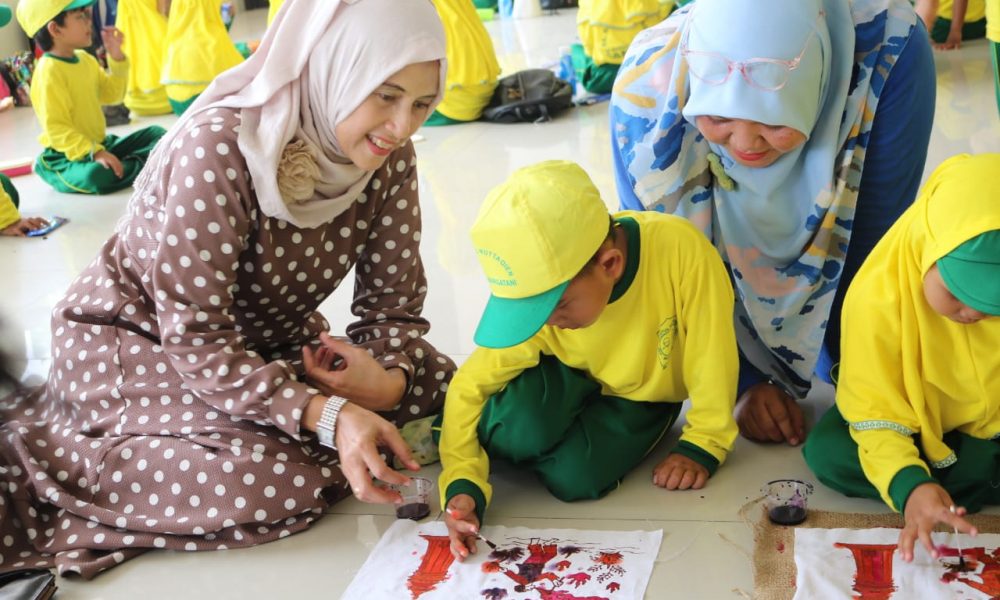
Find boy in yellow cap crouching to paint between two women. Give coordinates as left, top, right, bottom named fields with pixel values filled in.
left=439, top=161, right=738, bottom=560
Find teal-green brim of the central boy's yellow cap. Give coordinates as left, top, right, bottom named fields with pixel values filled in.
left=473, top=281, right=569, bottom=348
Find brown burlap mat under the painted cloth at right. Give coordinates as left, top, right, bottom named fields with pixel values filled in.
left=741, top=501, right=1000, bottom=600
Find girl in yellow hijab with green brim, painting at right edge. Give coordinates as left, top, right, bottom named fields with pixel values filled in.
left=803, top=154, right=1000, bottom=561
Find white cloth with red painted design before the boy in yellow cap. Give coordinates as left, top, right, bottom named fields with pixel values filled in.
left=341, top=520, right=663, bottom=600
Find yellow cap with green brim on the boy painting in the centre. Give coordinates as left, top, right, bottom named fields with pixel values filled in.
left=471, top=160, right=610, bottom=348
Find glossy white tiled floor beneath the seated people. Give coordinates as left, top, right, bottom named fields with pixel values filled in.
left=0, top=5, right=1000, bottom=599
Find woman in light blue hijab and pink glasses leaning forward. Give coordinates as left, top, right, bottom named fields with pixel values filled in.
left=610, top=0, right=935, bottom=445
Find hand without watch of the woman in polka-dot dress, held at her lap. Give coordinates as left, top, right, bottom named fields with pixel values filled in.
left=302, top=333, right=406, bottom=411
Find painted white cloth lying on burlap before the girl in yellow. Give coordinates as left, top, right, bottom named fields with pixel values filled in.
left=795, top=528, right=1000, bottom=600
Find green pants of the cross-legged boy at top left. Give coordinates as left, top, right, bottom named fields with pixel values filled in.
left=35, top=125, right=166, bottom=194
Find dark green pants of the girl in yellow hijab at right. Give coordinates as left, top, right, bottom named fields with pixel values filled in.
left=802, top=405, right=1000, bottom=512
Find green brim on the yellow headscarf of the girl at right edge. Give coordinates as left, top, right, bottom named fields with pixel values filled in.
left=937, top=229, right=1000, bottom=315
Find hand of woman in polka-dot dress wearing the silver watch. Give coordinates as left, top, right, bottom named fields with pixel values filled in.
left=302, top=396, right=420, bottom=504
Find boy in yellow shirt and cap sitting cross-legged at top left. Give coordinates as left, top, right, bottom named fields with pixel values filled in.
left=17, top=0, right=165, bottom=194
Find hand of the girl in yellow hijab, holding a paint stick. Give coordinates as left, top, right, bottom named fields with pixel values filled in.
left=899, top=483, right=979, bottom=562
